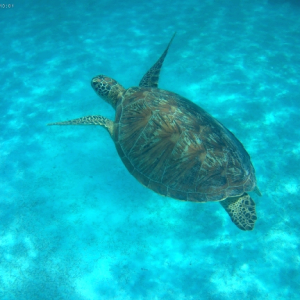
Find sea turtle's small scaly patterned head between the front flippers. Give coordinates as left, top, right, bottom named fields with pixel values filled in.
left=91, top=75, right=125, bottom=108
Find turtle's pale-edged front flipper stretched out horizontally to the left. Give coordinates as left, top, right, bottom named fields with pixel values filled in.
left=48, top=116, right=114, bottom=136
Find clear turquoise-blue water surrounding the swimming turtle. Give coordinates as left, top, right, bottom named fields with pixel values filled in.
left=0, top=0, right=300, bottom=300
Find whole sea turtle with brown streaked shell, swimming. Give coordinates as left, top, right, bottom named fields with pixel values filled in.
left=49, top=34, right=260, bottom=230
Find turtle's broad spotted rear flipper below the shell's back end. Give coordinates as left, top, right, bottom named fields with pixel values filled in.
left=220, top=193, right=257, bottom=230
